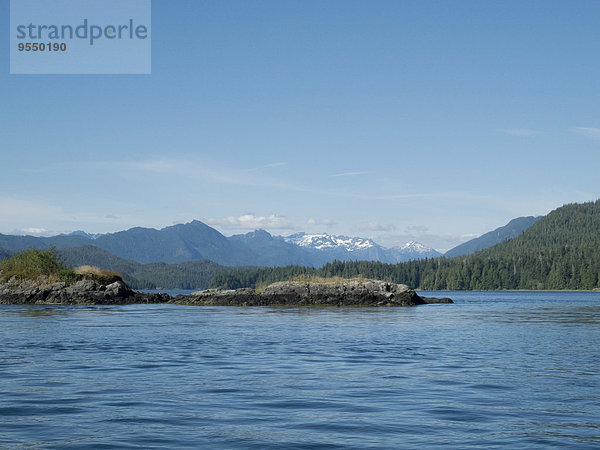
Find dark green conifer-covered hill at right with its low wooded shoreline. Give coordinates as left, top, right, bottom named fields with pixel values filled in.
left=212, top=201, right=600, bottom=289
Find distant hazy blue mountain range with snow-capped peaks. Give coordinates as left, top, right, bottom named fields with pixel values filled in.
left=0, top=220, right=441, bottom=267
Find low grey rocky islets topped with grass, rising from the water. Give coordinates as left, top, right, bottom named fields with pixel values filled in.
left=0, top=277, right=452, bottom=306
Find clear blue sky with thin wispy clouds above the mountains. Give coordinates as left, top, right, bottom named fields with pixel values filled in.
left=0, top=0, right=600, bottom=251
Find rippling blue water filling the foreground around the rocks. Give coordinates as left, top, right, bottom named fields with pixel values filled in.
left=0, top=292, right=600, bottom=449
